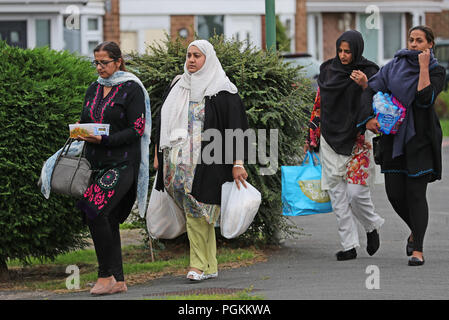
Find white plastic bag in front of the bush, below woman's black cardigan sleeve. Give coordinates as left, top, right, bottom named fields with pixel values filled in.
left=220, top=181, right=262, bottom=239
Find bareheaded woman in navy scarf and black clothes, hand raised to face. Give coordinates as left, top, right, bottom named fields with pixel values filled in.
left=364, top=26, right=445, bottom=266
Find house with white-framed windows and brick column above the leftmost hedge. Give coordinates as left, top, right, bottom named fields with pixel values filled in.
left=0, top=0, right=120, bottom=56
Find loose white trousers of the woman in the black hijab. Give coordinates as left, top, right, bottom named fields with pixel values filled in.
left=328, top=179, right=385, bottom=251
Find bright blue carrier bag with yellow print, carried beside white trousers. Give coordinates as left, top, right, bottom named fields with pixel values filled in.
left=281, top=152, right=332, bottom=216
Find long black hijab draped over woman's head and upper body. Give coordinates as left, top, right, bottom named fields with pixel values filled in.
left=318, top=30, right=379, bottom=155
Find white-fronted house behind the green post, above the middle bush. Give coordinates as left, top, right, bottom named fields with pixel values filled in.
left=120, top=0, right=307, bottom=52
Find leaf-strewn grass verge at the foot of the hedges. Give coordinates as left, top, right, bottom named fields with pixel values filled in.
left=0, top=244, right=266, bottom=299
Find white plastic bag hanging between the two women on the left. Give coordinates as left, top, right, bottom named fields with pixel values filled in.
left=146, top=176, right=186, bottom=239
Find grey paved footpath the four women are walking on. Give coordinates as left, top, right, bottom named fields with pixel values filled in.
left=12, top=143, right=449, bottom=300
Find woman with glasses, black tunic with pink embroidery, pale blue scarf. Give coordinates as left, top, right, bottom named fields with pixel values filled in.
left=77, top=42, right=151, bottom=294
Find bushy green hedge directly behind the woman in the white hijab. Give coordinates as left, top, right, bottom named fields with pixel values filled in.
left=127, top=36, right=314, bottom=243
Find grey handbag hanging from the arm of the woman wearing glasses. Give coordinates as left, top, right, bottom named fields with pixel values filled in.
left=51, top=138, right=92, bottom=198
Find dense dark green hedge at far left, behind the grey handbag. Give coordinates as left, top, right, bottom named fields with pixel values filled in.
left=0, top=42, right=96, bottom=271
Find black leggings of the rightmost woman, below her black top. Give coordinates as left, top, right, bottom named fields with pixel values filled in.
left=385, top=173, right=430, bottom=252
